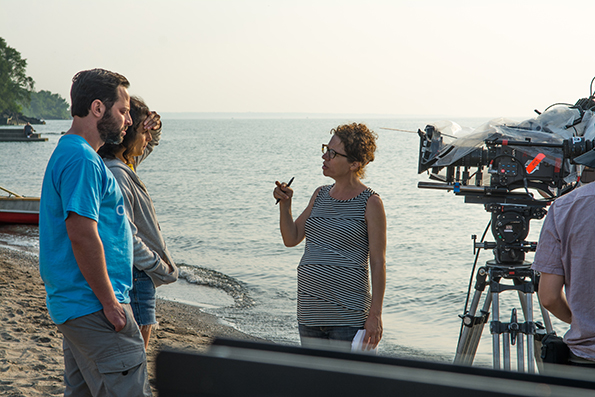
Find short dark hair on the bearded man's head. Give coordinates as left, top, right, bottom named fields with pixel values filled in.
left=70, top=69, right=130, bottom=117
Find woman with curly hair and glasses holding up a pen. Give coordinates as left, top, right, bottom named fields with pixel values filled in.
left=273, top=123, right=386, bottom=350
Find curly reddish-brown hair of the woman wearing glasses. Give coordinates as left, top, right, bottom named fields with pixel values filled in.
left=330, top=123, right=378, bottom=178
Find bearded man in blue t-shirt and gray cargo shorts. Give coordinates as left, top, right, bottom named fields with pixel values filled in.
left=39, top=69, right=151, bottom=396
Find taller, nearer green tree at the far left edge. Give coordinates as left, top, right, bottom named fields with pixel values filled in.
left=0, top=37, right=35, bottom=114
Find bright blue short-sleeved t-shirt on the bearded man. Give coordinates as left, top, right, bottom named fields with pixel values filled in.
left=39, top=135, right=133, bottom=324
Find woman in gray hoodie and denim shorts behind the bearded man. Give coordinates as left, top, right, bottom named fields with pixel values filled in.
left=98, top=97, right=178, bottom=349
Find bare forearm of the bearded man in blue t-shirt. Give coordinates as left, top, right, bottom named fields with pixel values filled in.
left=66, top=212, right=126, bottom=332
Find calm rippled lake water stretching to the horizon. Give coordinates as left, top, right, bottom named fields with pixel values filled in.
left=0, top=116, right=566, bottom=365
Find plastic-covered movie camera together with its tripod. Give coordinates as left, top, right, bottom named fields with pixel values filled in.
left=418, top=88, right=595, bottom=372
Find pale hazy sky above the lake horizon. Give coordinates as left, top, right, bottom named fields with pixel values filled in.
left=0, top=0, right=595, bottom=118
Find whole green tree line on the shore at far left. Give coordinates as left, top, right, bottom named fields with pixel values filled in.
left=0, top=37, right=70, bottom=120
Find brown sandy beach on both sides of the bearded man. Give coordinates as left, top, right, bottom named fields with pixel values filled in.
left=0, top=248, right=264, bottom=396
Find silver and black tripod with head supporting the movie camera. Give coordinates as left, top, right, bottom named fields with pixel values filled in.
left=454, top=203, right=553, bottom=373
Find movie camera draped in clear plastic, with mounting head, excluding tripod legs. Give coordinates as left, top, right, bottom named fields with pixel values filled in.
left=418, top=97, right=595, bottom=264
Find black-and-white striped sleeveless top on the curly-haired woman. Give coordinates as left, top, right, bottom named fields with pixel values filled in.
left=297, top=185, right=376, bottom=327
